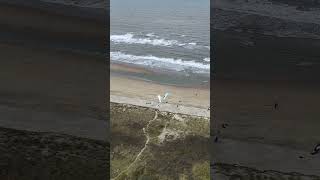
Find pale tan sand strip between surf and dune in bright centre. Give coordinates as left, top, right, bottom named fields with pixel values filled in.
left=110, top=64, right=210, bottom=113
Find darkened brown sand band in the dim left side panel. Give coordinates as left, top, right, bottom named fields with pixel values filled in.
left=0, top=44, right=108, bottom=140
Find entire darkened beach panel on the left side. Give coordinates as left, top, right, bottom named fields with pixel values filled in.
left=0, top=0, right=109, bottom=179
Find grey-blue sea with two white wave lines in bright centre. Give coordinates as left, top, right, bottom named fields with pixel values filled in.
left=110, top=0, right=210, bottom=81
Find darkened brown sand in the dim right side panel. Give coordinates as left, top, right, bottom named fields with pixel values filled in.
left=211, top=80, right=320, bottom=175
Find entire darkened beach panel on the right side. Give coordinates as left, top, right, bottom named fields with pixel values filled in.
left=210, top=0, right=320, bottom=179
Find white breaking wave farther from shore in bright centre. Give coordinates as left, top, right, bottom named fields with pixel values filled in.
left=110, top=33, right=201, bottom=49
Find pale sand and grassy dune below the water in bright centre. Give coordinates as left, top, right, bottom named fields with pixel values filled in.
left=110, top=64, right=210, bottom=180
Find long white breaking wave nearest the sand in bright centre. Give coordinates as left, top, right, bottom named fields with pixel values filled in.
left=110, top=51, right=210, bottom=73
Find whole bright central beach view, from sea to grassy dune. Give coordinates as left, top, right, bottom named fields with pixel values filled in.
left=110, top=0, right=210, bottom=180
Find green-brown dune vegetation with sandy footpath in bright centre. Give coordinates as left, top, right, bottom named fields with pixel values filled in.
left=111, top=104, right=209, bottom=180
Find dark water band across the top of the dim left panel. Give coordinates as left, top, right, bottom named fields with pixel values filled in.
left=0, top=0, right=108, bottom=54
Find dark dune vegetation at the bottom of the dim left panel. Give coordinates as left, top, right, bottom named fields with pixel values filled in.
left=0, top=128, right=110, bottom=180
